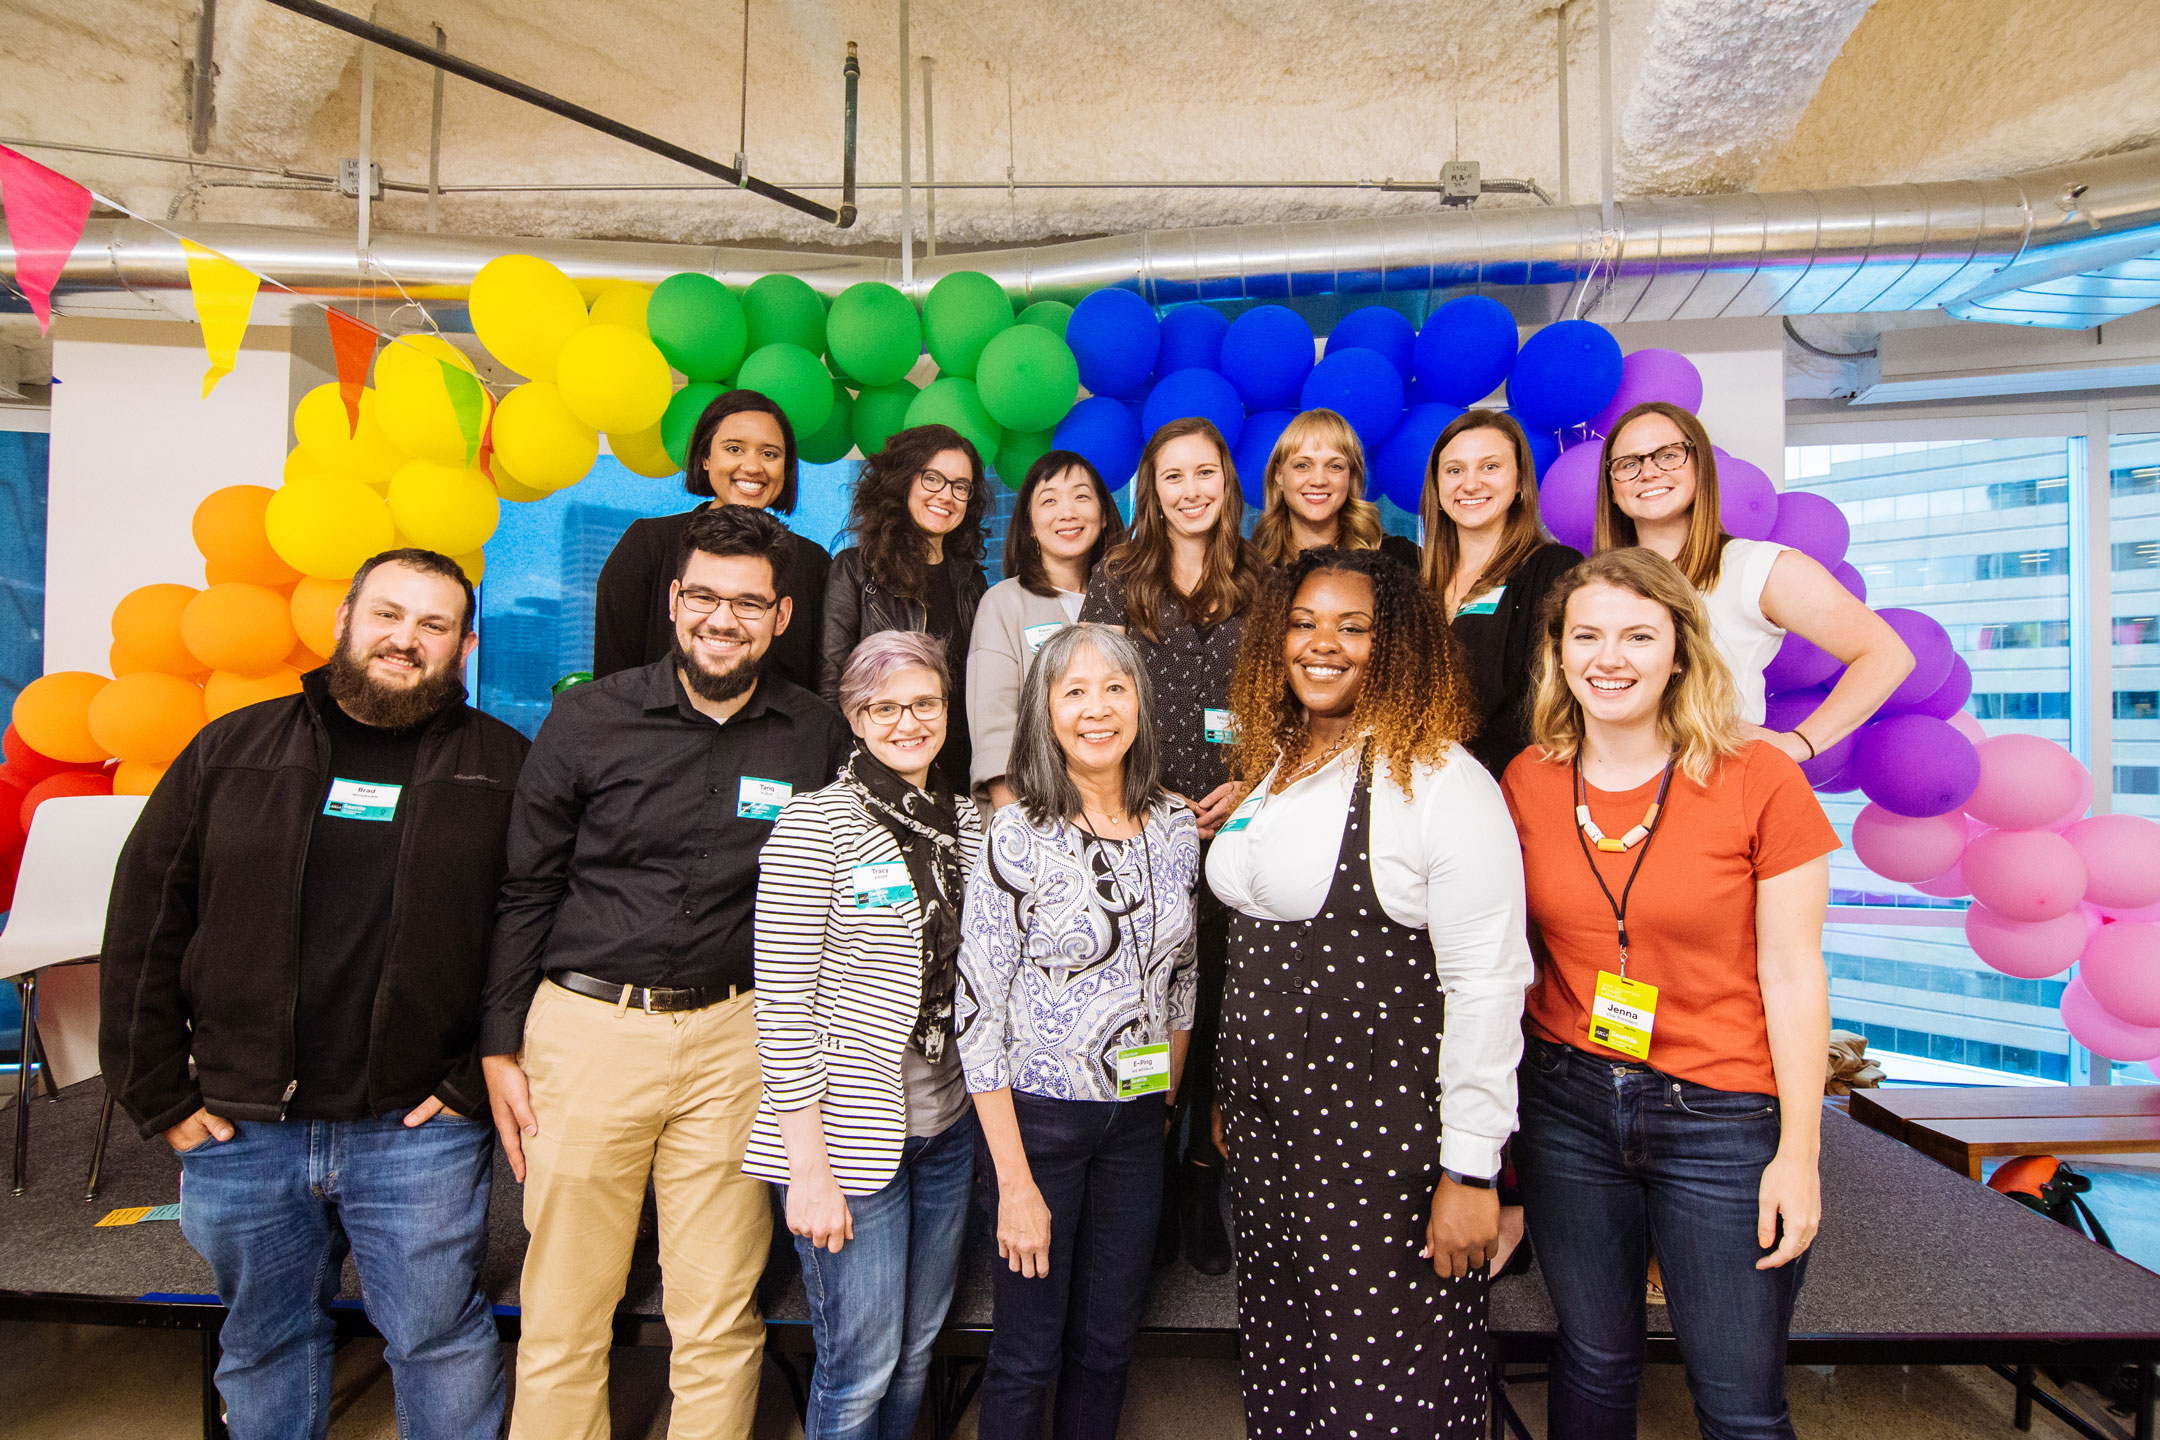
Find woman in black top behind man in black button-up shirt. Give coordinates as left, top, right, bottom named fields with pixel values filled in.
left=592, top=391, right=832, bottom=691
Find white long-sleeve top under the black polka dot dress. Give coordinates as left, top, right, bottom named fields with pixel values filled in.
left=1207, top=745, right=1534, bottom=1174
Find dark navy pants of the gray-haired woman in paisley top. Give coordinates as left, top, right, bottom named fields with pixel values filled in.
left=976, top=1090, right=1166, bottom=1440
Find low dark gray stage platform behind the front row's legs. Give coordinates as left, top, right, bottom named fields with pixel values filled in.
left=0, top=1079, right=2160, bottom=1440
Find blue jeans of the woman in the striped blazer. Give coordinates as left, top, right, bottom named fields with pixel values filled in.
left=780, top=1108, right=976, bottom=1440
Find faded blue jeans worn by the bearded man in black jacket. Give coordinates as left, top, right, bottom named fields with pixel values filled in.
left=179, top=1114, right=503, bottom=1440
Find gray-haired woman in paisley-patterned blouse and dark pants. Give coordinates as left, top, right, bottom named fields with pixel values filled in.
left=957, top=624, right=1201, bottom=1440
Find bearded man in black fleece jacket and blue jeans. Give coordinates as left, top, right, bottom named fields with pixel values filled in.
left=99, top=548, right=527, bottom=1440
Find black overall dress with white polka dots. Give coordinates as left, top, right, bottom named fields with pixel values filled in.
left=1218, top=769, right=1486, bottom=1440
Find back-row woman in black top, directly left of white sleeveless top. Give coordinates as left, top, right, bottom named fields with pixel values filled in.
left=1421, top=410, right=1583, bottom=779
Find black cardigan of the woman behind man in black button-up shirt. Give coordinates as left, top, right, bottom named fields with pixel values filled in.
left=592, top=510, right=832, bottom=691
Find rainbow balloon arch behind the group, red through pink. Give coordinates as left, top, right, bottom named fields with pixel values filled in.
left=0, top=255, right=2160, bottom=1062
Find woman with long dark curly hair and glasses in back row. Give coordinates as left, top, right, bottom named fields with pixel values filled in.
left=819, top=425, right=989, bottom=790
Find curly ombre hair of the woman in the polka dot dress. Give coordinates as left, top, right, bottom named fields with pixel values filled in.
left=1229, top=548, right=1477, bottom=794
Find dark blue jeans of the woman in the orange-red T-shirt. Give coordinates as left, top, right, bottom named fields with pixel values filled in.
left=1514, top=1036, right=1808, bottom=1440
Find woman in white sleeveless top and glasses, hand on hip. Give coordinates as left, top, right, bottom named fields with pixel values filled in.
left=1596, top=399, right=1912, bottom=762
